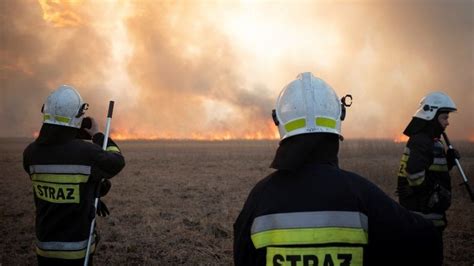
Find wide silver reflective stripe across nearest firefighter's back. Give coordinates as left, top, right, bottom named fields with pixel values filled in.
left=251, top=211, right=368, bottom=234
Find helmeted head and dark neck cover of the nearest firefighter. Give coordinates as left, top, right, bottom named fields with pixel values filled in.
left=271, top=72, right=352, bottom=170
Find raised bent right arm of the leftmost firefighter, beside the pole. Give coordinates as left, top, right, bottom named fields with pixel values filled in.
left=92, top=132, right=125, bottom=178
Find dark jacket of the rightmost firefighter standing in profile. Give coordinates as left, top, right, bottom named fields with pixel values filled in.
left=397, top=132, right=454, bottom=227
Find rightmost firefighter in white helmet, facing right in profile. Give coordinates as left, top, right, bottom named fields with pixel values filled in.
left=397, top=92, right=460, bottom=262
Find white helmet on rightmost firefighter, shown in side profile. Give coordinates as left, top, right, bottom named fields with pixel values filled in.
left=414, top=92, right=457, bottom=121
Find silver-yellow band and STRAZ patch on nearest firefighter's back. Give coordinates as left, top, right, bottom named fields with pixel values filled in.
left=251, top=211, right=368, bottom=265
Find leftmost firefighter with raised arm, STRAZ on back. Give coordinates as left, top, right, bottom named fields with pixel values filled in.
left=23, top=85, right=125, bottom=265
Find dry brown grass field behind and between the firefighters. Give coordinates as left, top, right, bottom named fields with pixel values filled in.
left=0, top=139, right=474, bottom=266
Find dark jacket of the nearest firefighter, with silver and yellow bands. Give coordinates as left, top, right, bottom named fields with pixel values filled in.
left=234, top=134, right=441, bottom=266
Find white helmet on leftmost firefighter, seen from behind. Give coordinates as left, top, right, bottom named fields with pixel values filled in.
left=41, top=85, right=88, bottom=128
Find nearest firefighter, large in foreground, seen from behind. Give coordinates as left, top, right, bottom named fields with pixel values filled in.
left=234, top=72, right=441, bottom=266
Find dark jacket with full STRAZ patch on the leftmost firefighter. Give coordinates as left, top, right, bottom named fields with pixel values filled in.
left=23, top=129, right=125, bottom=259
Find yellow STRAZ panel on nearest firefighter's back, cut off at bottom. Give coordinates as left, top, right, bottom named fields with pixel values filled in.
left=267, top=247, right=363, bottom=266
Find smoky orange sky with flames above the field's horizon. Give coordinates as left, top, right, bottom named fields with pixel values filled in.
left=0, top=0, right=474, bottom=141
